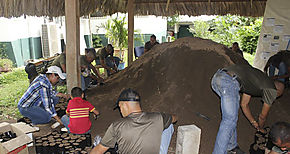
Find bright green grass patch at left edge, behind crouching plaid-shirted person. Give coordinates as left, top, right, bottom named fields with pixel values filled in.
left=0, top=69, right=29, bottom=120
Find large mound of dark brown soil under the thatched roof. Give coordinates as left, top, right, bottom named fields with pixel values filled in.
left=88, top=38, right=289, bottom=154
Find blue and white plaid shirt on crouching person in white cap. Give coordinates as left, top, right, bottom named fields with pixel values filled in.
left=18, top=74, right=57, bottom=117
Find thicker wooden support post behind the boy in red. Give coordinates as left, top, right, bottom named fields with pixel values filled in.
left=65, top=0, right=81, bottom=93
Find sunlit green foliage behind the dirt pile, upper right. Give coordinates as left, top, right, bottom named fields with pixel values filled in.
left=190, top=15, right=263, bottom=53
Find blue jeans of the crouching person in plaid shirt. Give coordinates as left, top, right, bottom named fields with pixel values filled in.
left=18, top=106, right=51, bottom=124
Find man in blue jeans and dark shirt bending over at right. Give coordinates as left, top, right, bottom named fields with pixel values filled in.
left=211, top=65, right=284, bottom=154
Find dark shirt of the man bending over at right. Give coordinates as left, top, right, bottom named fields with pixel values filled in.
left=224, top=65, right=277, bottom=105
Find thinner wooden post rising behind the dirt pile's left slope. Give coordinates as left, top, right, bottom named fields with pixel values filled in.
left=127, top=0, right=134, bottom=66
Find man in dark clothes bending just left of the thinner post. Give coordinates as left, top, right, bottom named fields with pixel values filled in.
left=95, top=44, right=121, bottom=75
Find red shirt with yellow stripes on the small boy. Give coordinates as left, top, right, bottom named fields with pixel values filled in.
left=66, top=97, right=95, bottom=134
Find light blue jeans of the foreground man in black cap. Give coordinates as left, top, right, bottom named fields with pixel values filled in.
left=159, top=124, right=174, bottom=154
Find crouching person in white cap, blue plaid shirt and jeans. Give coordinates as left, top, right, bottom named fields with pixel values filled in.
left=18, top=66, right=68, bottom=125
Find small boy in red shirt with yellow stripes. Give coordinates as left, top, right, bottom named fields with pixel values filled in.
left=61, top=87, right=100, bottom=134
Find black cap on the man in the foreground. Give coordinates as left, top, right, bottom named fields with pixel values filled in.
left=114, top=88, right=140, bottom=110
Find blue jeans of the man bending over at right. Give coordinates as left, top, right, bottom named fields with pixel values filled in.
left=211, top=70, right=240, bottom=154
